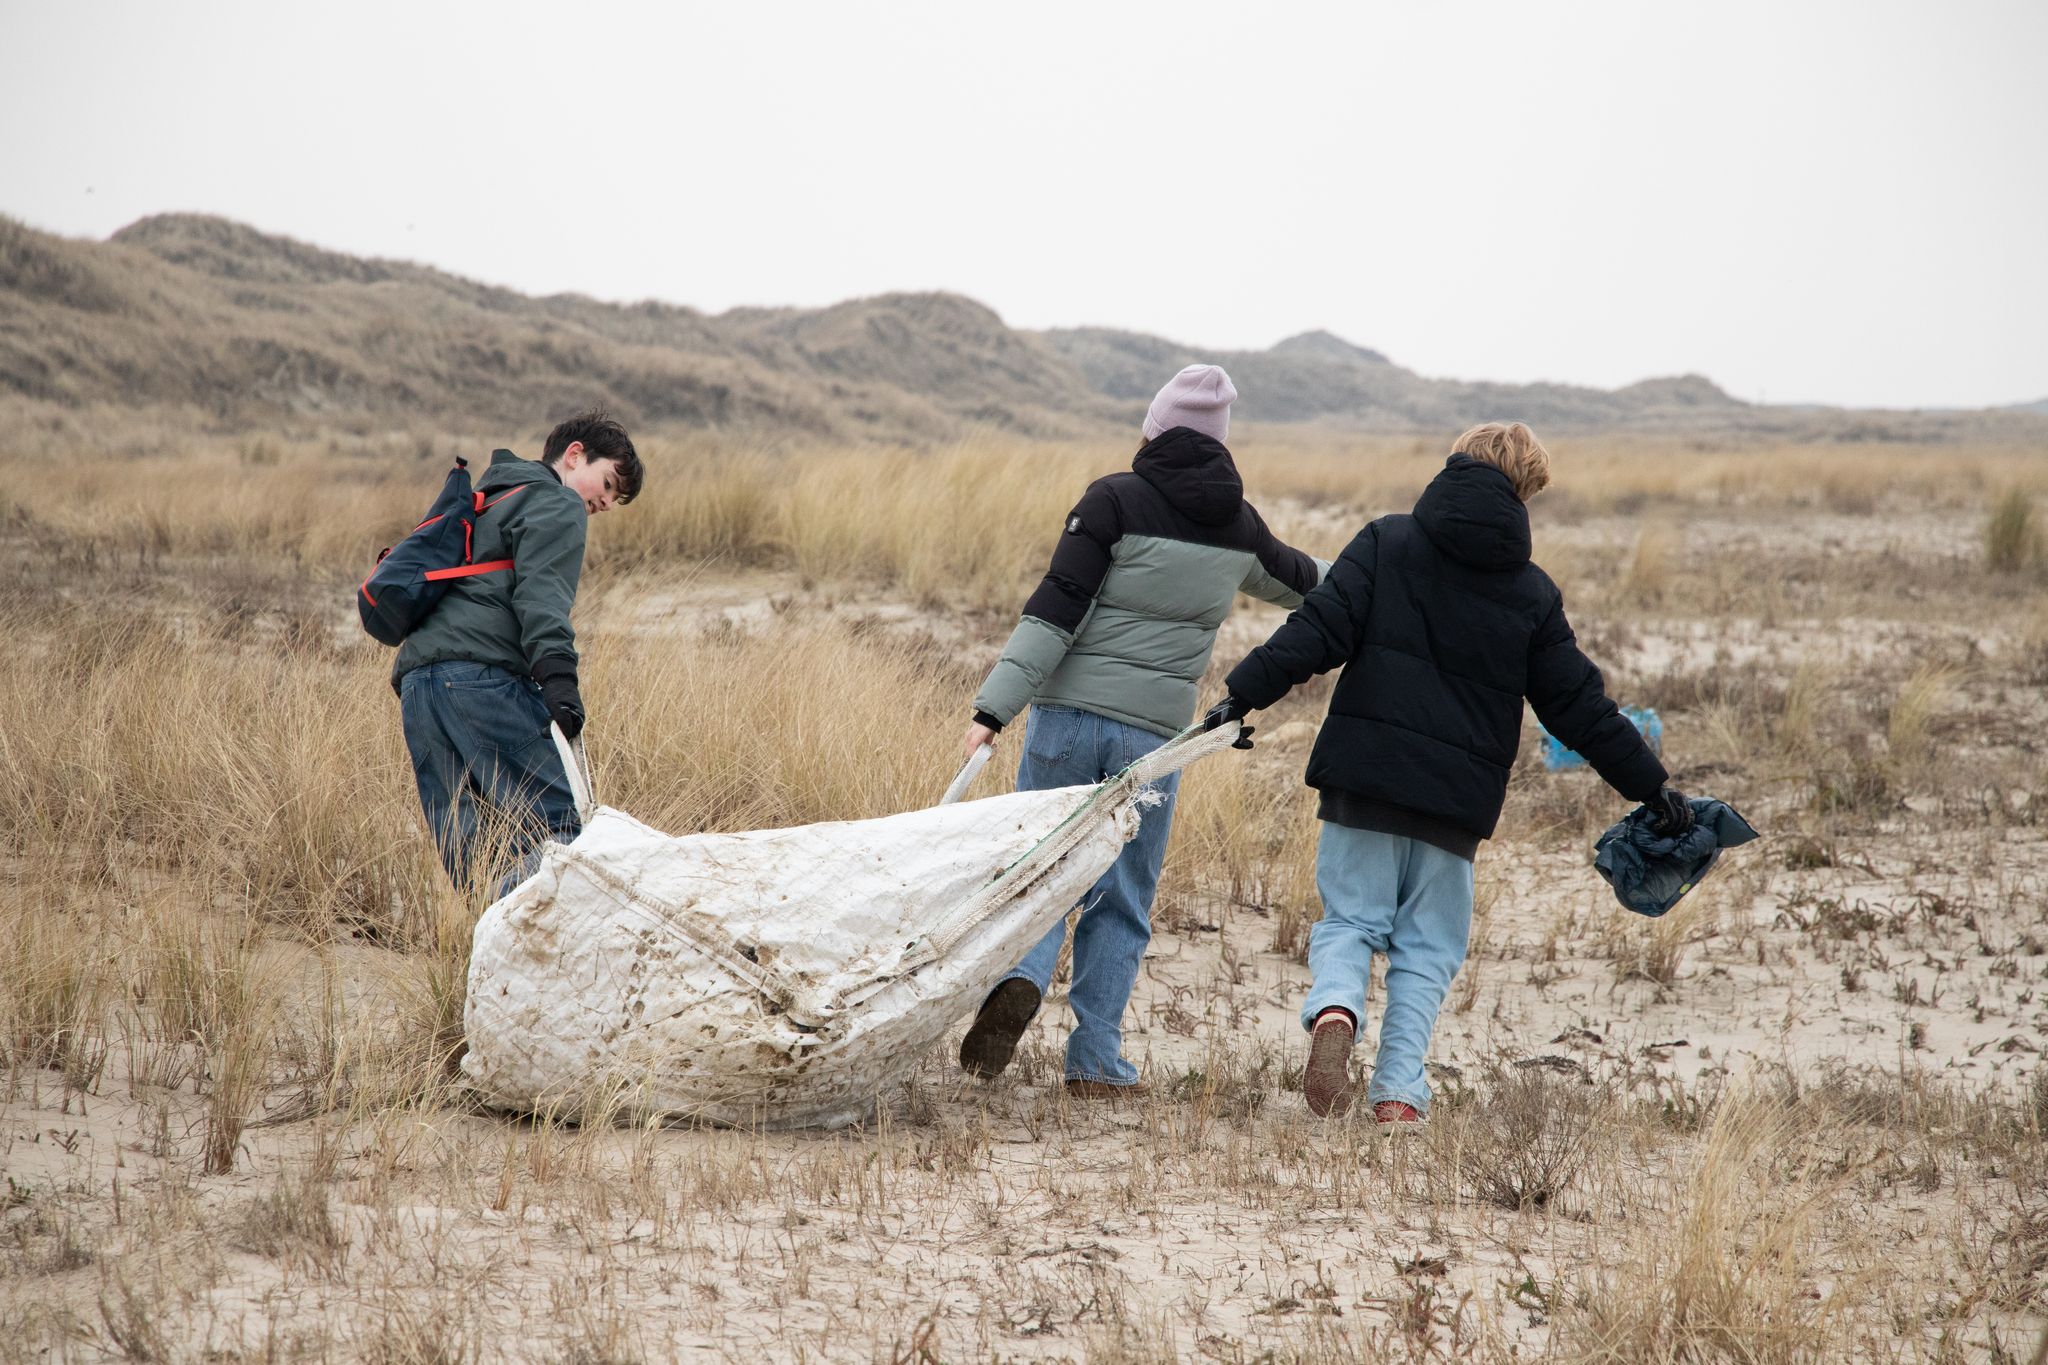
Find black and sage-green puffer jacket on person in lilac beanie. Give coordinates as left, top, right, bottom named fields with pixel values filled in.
left=975, top=428, right=1329, bottom=735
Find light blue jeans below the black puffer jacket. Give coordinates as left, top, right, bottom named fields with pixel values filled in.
left=1300, top=821, right=1473, bottom=1113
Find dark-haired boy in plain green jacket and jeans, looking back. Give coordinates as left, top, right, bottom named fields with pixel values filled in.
left=391, top=411, right=643, bottom=894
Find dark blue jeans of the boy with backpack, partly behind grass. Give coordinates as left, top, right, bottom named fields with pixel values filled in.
left=397, top=661, right=582, bottom=896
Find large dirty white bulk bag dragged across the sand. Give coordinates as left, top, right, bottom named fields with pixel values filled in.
left=463, top=724, right=1237, bottom=1128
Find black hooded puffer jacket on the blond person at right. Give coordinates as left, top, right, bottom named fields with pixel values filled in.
left=1229, top=454, right=1665, bottom=857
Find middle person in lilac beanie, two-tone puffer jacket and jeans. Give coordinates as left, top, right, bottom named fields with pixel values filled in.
left=961, top=364, right=1329, bottom=1099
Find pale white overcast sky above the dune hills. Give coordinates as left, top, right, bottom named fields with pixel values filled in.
left=0, top=0, right=2048, bottom=407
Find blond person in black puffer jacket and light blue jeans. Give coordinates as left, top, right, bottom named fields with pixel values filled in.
left=1206, top=422, right=1690, bottom=1124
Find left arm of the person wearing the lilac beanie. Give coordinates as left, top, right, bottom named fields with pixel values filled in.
left=963, top=481, right=1122, bottom=753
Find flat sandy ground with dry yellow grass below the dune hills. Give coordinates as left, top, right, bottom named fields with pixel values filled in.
left=0, top=409, right=2048, bottom=1365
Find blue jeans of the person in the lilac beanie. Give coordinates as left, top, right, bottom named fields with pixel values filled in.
left=1004, top=706, right=1180, bottom=1085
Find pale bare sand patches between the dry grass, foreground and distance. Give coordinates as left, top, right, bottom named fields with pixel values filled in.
left=0, top=514, right=2048, bottom=1361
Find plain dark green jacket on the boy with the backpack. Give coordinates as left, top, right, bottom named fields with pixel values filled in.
left=391, top=450, right=590, bottom=688
